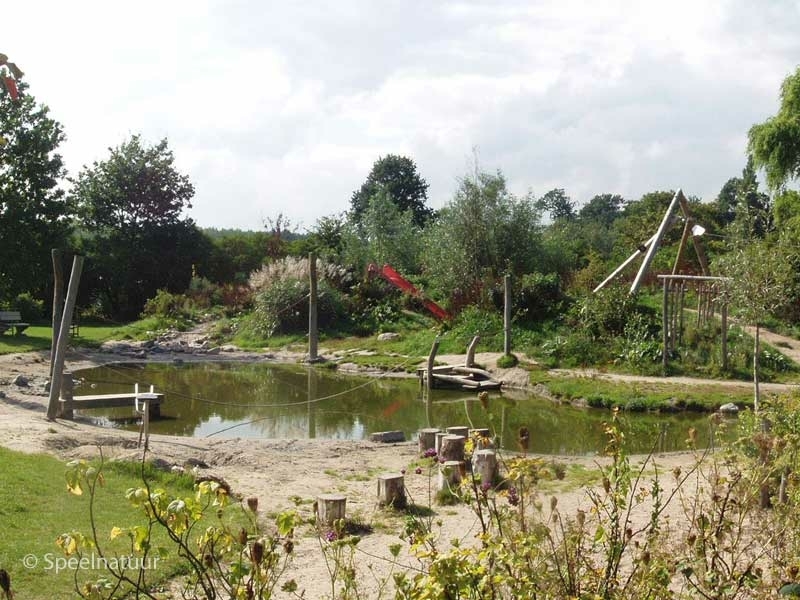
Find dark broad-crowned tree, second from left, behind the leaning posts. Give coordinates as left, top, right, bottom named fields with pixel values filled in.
left=71, top=135, right=202, bottom=319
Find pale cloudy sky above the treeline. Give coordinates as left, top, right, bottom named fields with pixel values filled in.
left=0, top=0, right=800, bottom=231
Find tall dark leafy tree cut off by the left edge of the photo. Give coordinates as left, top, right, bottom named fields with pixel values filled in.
left=0, top=69, right=70, bottom=303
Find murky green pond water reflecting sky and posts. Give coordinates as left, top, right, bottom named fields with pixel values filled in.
left=75, top=363, right=728, bottom=455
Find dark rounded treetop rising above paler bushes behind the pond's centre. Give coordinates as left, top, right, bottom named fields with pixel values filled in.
left=350, top=154, right=433, bottom=227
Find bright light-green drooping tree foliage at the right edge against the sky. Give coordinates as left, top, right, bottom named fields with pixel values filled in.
left=747, top=67, right=800, bottom=191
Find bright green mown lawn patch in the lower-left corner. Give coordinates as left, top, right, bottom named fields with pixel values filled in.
left=0, top=448, right=242, bottom=599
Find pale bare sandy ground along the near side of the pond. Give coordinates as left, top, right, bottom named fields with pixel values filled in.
left=0, top=344, right=712, bottom=598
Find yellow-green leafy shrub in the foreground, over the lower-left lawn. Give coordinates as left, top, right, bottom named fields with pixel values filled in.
left=56, top=452, right=300, bottom=600
